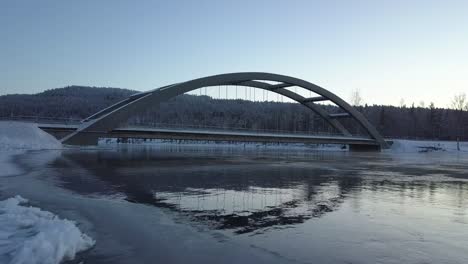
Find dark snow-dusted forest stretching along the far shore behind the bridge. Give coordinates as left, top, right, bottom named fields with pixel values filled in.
left=0, top=86, right=468, bottom=140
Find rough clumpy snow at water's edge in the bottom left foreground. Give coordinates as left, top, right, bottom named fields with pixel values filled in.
left=0, top=196, right=95, bottom=264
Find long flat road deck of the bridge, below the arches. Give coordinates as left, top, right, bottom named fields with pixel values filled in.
left=40, top=126, right=380, bottom=150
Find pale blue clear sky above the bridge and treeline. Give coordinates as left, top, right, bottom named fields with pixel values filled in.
left=0, top=0, right=468, bottom=106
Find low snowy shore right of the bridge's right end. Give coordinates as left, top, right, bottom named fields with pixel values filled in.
left=390, top=139, right=468, bottom=152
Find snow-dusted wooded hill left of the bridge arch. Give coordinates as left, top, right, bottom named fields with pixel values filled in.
left=0, top=86, right=137, bottom=119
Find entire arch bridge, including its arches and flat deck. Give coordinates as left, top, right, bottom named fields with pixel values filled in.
left=43, top=72, right=388, bottom=149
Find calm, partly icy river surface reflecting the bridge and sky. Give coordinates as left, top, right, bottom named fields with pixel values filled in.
left=0, top=146, right=468, bottom=263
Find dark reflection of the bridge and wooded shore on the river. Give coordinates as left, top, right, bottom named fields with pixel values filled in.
left=48, top=148, right=468, bottom=234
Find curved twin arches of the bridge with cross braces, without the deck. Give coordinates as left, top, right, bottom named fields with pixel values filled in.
left=62, top=72, right=388, bottom=148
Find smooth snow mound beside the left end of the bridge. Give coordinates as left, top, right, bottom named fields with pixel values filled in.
left=0, top=121, right=62, bottom=151
